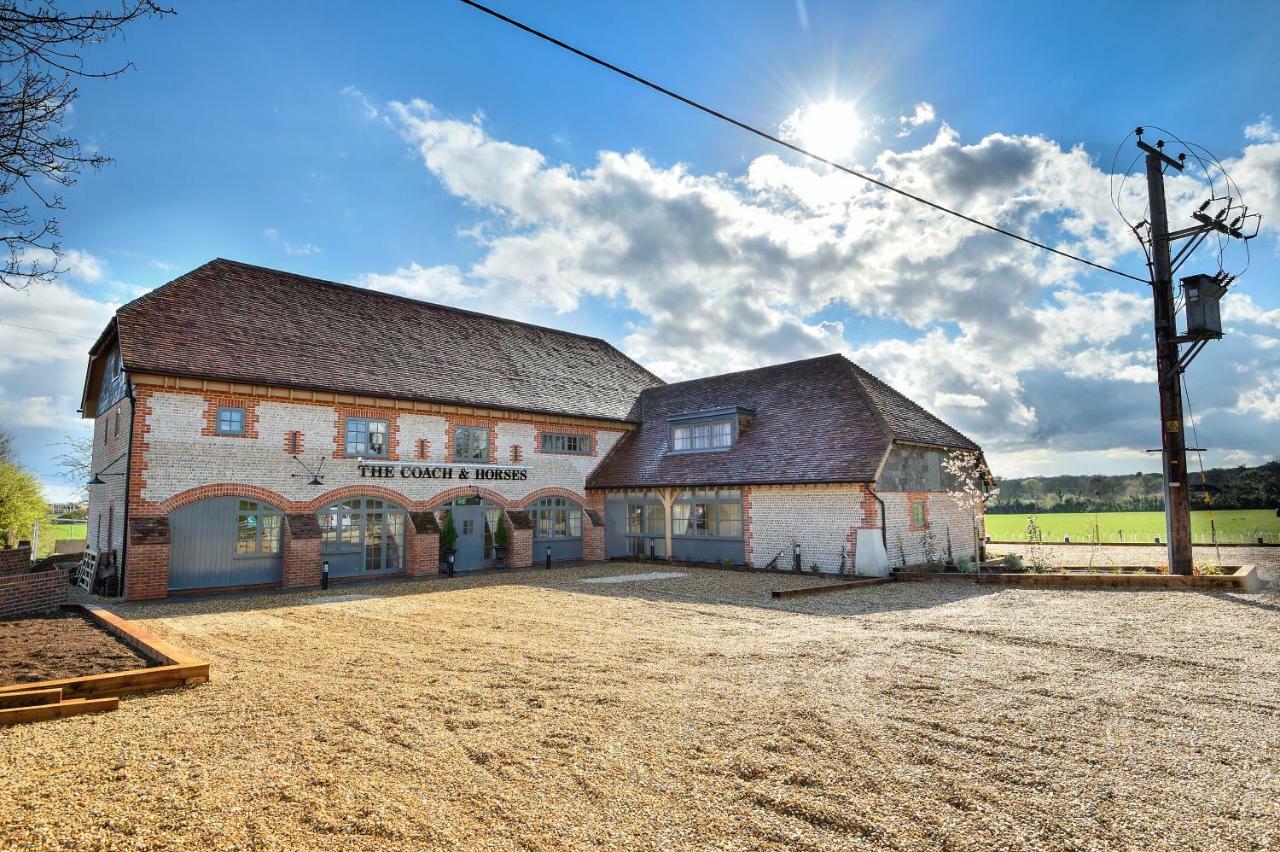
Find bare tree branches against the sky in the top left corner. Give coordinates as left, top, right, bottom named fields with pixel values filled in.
left=0, top=0, right=173, bottom=289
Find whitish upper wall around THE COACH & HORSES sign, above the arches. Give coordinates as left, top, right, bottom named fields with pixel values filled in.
left=142, top=393, right=622, bottom=503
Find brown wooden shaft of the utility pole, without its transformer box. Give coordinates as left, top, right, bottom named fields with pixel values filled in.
left=1138, top=133, right=1192, bottom=576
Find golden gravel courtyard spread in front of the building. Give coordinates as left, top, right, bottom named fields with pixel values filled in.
left=0, top=563, right=1280, bottom=849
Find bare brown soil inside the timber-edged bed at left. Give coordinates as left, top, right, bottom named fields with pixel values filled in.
left=0, top=613, right=152, bottom=685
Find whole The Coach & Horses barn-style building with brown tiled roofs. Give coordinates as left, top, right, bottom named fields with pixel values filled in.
left=82, top=260, right=980, bottom=599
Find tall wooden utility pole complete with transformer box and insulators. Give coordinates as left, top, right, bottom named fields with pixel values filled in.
left=1134, top=127, right=1261, bottom=576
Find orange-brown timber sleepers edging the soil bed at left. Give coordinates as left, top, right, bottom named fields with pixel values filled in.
left=0, top=604, right=209, bottom=724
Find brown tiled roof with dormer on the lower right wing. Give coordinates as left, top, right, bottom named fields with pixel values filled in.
left=588, top=354, right=978, bottom=487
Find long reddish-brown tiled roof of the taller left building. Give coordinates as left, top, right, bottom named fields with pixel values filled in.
left=116, top=260, right=662, bottom=420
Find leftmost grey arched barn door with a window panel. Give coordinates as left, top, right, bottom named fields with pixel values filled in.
left=169, top=498, right=284, bottom=591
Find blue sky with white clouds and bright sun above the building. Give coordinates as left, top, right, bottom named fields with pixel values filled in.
left=0, top=0, right=1280, bottom=496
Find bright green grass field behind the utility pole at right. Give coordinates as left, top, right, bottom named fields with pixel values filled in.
left=987, top=509, right=1280, bottom=542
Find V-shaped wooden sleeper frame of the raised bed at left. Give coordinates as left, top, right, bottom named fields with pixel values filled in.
left=0, top=604, right=209, bottom=724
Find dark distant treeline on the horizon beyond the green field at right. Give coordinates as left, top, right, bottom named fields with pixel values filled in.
left=987, top=458, right=1280, bottom=514
